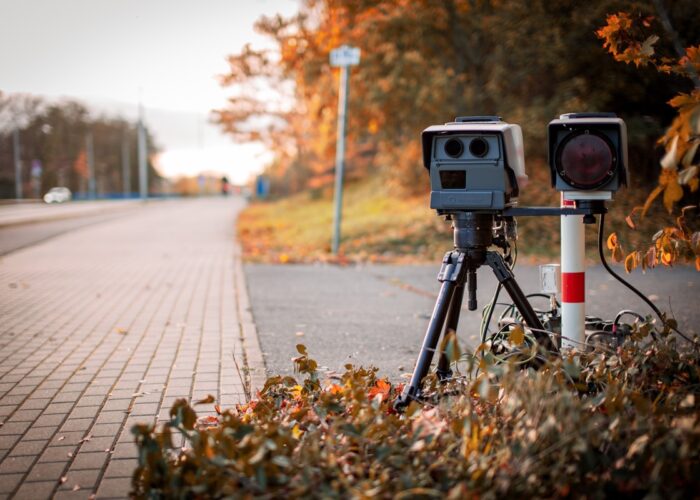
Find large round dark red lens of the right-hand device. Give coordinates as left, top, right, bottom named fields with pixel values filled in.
left=556, top=130, right=616, bottom=189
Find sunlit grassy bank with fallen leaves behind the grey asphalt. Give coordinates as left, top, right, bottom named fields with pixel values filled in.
left=238, top=166, right=674, bottom=263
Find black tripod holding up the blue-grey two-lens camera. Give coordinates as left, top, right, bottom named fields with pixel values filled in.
left=396, top=212, right=558, bottom=408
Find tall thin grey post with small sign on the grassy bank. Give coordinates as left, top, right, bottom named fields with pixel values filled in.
left=331, top=45, right=360, bottom=255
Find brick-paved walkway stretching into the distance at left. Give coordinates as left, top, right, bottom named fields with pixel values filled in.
left=0, top=199, right=264, bottom=498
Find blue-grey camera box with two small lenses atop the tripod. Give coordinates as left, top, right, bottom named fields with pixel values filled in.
left=421, top=116, right=527, bottom=213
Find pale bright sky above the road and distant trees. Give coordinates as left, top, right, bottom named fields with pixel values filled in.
left=0, top=0, right=298, bottom=183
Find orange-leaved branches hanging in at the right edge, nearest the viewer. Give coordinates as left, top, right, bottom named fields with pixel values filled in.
left=597, top=0, right=700, bottom=272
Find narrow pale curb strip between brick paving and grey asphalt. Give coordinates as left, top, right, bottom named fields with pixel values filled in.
left=233, top=242, right=267, bottom=397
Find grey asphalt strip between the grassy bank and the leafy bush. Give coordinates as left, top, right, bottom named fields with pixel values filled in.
left=245, top=263, right=700, bottom=378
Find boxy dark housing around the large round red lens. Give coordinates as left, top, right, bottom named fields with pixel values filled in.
left=547, top=113, right=629, bottom=200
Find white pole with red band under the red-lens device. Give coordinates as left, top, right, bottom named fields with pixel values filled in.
left=561, top=193, right=586, bottom=348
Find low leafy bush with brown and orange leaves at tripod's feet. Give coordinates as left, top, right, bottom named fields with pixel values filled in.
left=133, top=334, right=700, bottom=498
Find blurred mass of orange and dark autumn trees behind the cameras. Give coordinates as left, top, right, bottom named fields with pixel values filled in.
left=214, top=0, right=690, bottom=198
